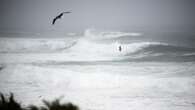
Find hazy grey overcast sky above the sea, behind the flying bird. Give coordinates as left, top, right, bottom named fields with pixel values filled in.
left=0, top=0, right=195, bottom=32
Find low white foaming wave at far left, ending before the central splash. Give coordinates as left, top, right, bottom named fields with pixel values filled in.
left=0, top=38, right=76, bottom=53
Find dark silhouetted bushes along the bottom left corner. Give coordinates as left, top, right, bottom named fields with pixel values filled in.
left=0, top=93, right=79, bottom=110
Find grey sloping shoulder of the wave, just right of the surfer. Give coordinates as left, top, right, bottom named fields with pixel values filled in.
left=121, top=42, right=195, bottom=61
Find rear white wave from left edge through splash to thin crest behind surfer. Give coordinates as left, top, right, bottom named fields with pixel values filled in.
left=0, top=29, right=141, bottom=53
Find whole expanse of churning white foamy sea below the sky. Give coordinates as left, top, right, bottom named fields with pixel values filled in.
left=0, top=29, right=195, bottom=110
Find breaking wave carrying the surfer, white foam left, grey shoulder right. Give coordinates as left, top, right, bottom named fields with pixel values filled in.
left=71, top=41, right=195, bottom=61
